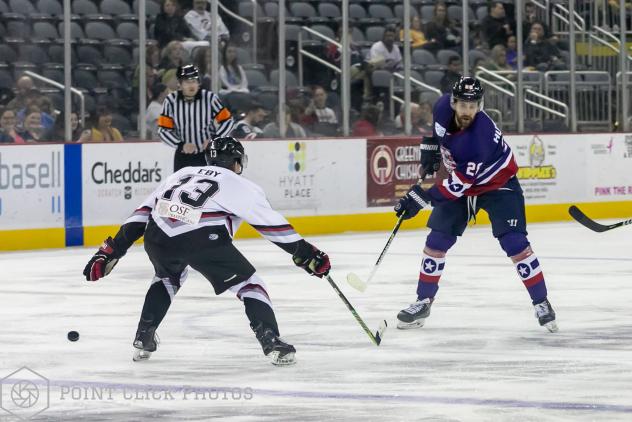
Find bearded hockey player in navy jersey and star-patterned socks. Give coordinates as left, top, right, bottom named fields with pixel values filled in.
left=395, top=77, right=557, bottom=332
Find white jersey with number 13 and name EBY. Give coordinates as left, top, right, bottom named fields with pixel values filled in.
left=125, top=166, right=302, bottom=246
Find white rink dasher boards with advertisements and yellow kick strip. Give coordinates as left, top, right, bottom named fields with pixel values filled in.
left=0, top=133, right=632, bottom=250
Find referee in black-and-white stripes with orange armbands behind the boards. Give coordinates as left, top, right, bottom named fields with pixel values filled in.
left=158, top=64, right=233, bottom=172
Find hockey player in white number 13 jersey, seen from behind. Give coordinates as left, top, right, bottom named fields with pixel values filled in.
left=83, top=138, right=331, bottom=365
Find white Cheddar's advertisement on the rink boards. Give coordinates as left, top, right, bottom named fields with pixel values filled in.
left=81, top=142, right=174, bottom=226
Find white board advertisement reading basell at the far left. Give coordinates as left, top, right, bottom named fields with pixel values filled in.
left=0, top=145, right=64, bottom=230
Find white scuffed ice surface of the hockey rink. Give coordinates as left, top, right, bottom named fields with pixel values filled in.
left=0, top=223, right=632, bottom=422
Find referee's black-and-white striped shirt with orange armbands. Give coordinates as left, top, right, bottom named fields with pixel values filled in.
left=158, top=89, right=234, bottom=151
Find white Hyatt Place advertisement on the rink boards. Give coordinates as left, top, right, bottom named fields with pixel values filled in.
left=244, top=139, right=366, bottom=215
